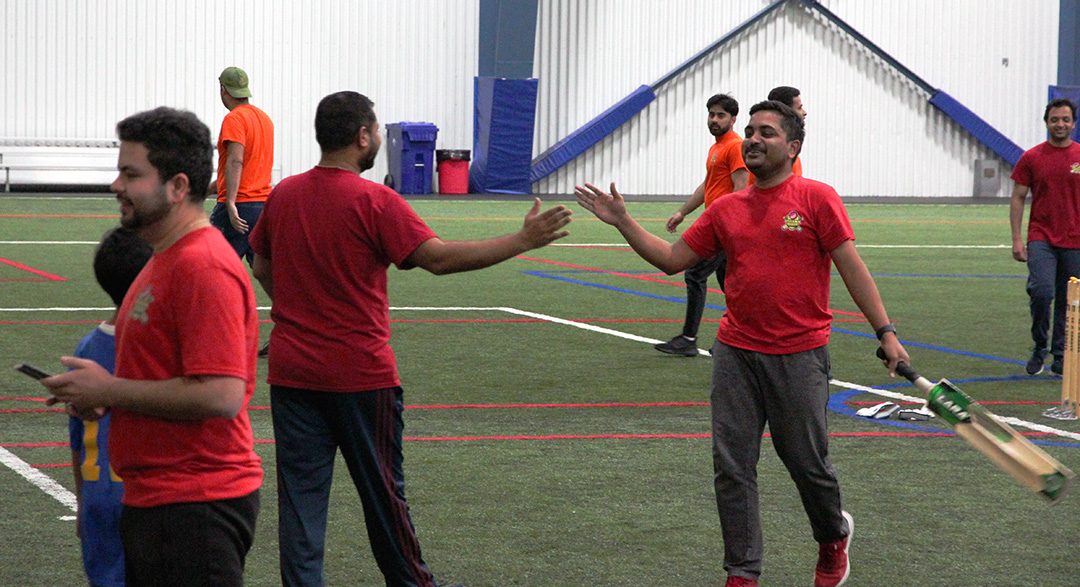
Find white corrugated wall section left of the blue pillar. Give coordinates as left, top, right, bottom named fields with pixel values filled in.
left=0, top=0, right=480, bottom=185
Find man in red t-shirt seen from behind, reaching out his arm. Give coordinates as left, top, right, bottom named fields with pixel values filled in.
left=252, top=92, right=570, bottom=587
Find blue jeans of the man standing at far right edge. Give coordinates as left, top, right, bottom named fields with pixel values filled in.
left=1027, top=241, right=1080, bottom=357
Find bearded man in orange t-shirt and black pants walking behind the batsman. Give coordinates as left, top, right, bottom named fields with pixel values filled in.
left=653, top=94, right=747, bottom=357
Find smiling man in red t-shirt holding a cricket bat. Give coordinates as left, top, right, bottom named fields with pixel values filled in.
left=576, top=101, right=909, bottom=587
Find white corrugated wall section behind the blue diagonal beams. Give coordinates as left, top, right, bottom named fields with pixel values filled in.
left=534, top=0, right=1058, bottom=196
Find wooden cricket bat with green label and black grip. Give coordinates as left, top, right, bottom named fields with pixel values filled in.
left=878, top=349, right=1076, bottom=503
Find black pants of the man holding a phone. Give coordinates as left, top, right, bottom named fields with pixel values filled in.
left=120, top=490, right=259, bottom=587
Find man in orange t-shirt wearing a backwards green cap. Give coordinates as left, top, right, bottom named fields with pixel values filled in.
left=210, top=67, right=273, bottom=264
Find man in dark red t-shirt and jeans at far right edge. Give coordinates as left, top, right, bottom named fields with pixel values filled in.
left=1009, top=98, right=1080, bottom=376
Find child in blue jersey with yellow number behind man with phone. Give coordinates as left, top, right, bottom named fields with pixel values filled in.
left=68, top=227, right=153, bottom=587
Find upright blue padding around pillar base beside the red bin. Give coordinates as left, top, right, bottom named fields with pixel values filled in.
left=469, top=78, right=539, bottom=193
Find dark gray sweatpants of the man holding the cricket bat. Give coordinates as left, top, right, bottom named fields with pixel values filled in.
left=711, top=341, right=848, bottom=578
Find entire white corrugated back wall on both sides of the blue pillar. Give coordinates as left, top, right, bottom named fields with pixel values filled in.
left=0, top=0, right=1058, bottom=196
